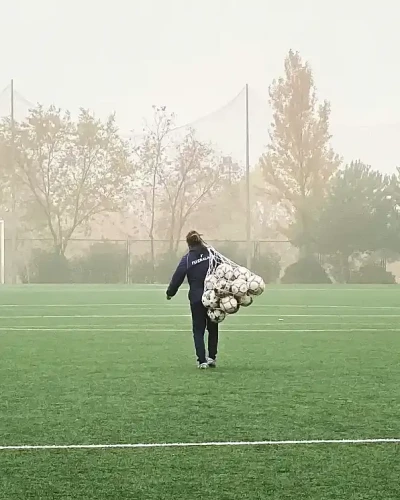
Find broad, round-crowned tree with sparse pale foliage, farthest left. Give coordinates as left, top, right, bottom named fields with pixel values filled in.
left=15, top=106, right=130, bottom=255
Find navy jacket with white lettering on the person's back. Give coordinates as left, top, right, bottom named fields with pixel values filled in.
left=167, top=245, right=210, bottom=304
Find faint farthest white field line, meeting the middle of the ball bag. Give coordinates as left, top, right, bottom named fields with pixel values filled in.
left=0, top=303, right=400, bottom=310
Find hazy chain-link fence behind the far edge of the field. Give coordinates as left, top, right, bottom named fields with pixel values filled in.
left=5, top=239, right=298, bottom=283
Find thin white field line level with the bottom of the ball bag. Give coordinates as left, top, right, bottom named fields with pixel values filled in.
left=0, top=313, right=400, bottom=320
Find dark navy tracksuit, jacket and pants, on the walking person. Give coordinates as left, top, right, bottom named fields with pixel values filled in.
left=167, top=245, right=218, bottom=363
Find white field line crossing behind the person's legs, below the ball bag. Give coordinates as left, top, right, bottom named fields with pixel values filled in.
left=0, top=326, right=400, bottom=334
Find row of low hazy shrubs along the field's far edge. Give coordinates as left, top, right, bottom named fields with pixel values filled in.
left=20, top=242, right=396, bottom=284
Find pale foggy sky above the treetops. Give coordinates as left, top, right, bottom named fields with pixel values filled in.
left=0, top=0, right=400, bottom=171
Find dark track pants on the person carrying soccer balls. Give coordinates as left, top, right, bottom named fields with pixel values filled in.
left=190, top=302, right=218, bottom=363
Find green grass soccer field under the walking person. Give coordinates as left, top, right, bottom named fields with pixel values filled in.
left=0, top=286, right=400, bottom=500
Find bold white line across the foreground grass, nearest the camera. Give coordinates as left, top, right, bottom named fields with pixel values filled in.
left=0, top=438, right=400, bottom=451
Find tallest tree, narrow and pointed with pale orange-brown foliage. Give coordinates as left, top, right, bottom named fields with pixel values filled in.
left=260, top=51, right=341, bottom=254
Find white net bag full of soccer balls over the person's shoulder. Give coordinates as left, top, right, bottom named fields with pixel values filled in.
left=202, top=247, right=265, bottom=323
